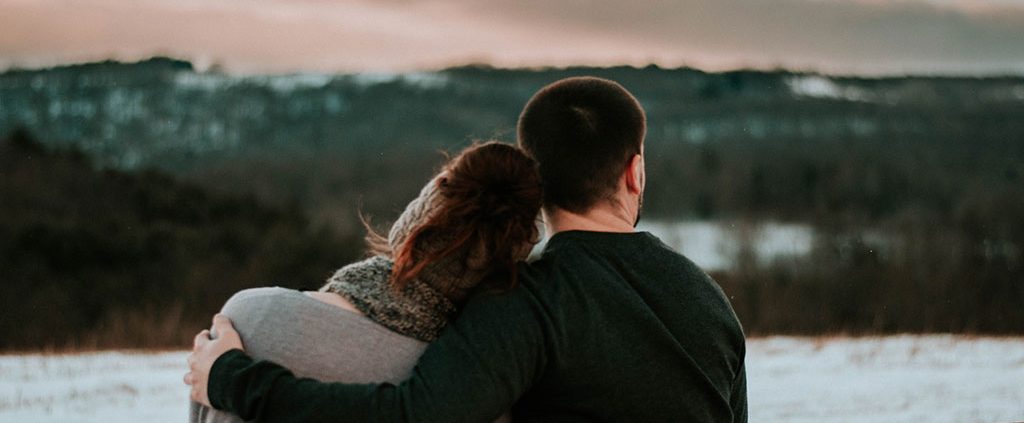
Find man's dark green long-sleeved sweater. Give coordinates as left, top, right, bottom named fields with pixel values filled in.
left=208, top=231, right=746, bottom=422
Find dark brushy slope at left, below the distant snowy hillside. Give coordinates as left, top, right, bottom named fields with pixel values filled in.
left=0, top=131, right=361, bottom=350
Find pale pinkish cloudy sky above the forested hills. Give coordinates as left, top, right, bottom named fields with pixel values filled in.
left=0, top=0, right=1024, bottom=76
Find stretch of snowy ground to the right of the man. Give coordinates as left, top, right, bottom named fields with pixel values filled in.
left=746, top=336, right=1024, bottom=422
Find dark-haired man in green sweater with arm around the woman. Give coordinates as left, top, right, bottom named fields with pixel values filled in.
left=185, top=78, right=746, bottom=422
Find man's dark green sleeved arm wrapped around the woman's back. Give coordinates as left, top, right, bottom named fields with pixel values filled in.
left=202, top=287, right=546, bottom=422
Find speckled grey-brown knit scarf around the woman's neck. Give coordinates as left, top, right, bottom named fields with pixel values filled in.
left=321, top=256, right=456, bottom=342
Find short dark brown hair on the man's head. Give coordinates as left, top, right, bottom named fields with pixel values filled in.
left=517, top=77, right=647, bottom=213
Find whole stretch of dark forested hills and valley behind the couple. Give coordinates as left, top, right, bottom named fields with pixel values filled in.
left=0, top=59, right=1024, bottom=349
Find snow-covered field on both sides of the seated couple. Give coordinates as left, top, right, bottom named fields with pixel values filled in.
left=0, top=336, right=1024, bottom=423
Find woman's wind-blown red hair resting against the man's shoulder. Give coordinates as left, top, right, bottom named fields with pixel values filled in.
left=391, top=141, right=543, bottom=300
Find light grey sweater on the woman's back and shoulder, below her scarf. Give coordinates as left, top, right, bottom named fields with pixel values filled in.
left=188, top=288, right=427, bottom=423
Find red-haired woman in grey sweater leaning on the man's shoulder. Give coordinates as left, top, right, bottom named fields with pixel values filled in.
left=189, top=141, right=541, bottom=422
